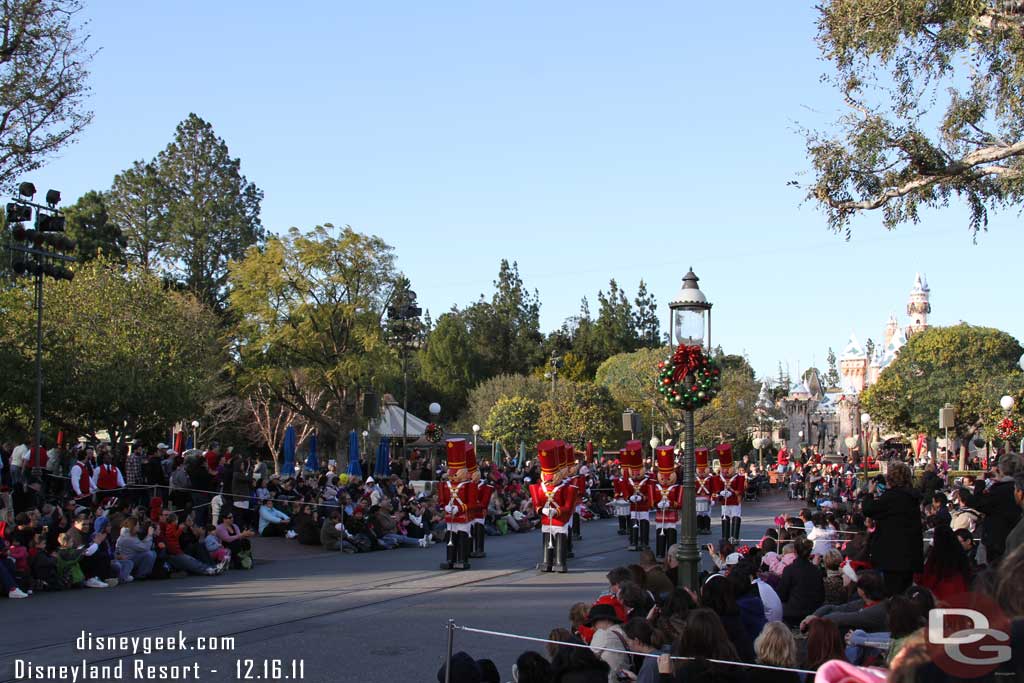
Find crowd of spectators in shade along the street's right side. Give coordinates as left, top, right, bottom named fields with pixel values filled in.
left=437, top=454, right=1024, bottom=683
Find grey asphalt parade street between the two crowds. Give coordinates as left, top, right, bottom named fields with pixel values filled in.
left=0, top=494, right=799, bottom=683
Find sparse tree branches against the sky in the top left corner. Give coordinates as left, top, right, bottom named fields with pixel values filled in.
left=0, top=0, right=92, bottom=188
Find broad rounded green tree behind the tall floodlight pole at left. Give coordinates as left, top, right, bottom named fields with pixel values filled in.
left=0, top=257, right=223, bottom=441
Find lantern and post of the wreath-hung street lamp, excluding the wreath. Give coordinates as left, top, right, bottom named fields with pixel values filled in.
left=669, top=268, right=712, bottom=590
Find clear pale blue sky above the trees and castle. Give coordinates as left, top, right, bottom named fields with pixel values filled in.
left=31, top=0, right=1024, bottom=375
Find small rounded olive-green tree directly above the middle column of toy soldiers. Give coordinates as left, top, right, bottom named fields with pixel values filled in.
left=538, top=382, right=622, bottom=447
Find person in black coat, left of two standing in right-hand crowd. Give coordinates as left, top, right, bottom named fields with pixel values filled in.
left=863, top=462, right=925, bottom=595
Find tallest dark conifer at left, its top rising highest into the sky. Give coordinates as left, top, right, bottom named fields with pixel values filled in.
left=156, top=114, right=264, bottom=308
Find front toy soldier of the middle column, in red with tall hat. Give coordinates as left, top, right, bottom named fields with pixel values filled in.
left=529, top=439, right=577, bottom=573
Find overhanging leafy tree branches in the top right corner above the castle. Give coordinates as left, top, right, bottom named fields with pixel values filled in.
left=807, top=0, right=1024, bottom=234
